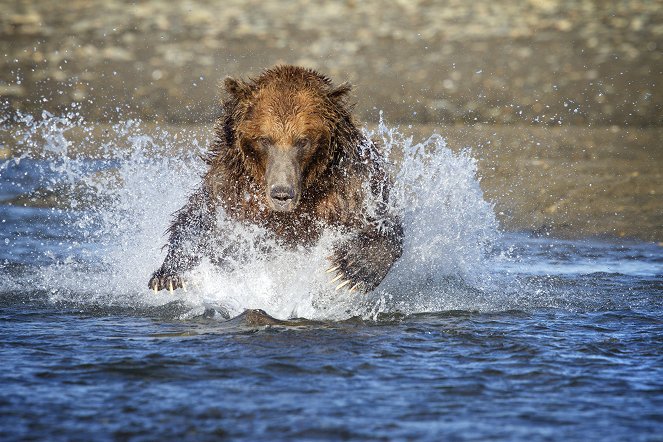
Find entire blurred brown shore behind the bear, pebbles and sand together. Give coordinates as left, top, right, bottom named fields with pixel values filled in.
left=0, top=0, right=663, bottom=241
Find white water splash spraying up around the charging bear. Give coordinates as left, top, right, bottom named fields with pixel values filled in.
left=0, top=113, right=508, bottom=319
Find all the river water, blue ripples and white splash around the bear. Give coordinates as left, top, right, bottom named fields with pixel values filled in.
left=0, top=114, right=663, bottom=440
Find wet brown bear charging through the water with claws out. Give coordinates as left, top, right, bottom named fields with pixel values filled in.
left=149, top=66, right=403, bottom=291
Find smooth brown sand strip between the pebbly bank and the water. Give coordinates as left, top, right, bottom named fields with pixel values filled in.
left=0, top=122, right=663, bottom=243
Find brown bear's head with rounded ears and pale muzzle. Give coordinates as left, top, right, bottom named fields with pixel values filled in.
left=223, top=66, right=360, bottom=212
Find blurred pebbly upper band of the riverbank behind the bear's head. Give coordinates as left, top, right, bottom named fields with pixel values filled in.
left=0, top=0, right=663, bottom=126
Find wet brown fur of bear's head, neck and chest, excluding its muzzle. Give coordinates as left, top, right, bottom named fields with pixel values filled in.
left=205, top=66, right=367, bottom=242
